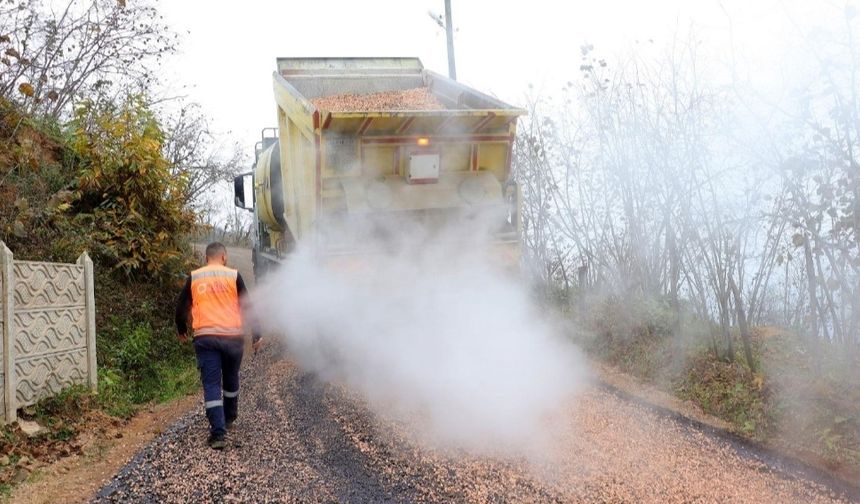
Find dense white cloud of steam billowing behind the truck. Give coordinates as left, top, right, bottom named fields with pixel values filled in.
left=254, top=219, right=585, bottom=452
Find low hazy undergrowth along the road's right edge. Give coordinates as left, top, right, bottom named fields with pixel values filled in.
left=571, top=298, right=860, bottom=468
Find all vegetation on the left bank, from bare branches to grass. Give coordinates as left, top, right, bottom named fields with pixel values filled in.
left=0, top=0, right=198, bottom=488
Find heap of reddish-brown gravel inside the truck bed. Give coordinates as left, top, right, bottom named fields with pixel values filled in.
left=311, top=87, right=447, bottom=112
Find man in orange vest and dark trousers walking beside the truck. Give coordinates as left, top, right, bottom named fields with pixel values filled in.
left=176, top=242, right=263, bottom=450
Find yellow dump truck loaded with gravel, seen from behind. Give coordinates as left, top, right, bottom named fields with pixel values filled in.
left=234, top=58, right=525, bottom=274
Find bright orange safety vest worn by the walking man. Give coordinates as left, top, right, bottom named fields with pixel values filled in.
left=191, top=265, right=243, bottom=337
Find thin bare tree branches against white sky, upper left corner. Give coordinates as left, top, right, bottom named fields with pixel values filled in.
left=0, top=0, right=176, bottom=118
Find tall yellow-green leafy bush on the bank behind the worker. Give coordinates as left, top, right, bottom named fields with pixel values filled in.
left=70, top=96, right=194, bottom=278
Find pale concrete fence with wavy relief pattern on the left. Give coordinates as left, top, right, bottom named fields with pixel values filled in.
left=0, top=241, right=98, bottom=423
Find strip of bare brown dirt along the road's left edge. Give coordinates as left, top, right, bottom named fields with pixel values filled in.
left=4, top=394, right=200, bottom=504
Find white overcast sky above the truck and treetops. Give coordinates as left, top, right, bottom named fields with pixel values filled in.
left=160, top=0, right=850, bottom=163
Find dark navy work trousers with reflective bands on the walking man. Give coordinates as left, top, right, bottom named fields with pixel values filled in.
left=194, top=336, right=245, bottom=434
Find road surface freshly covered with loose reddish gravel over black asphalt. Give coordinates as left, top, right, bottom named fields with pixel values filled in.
left=93, top=249, right=850, bottom=503
